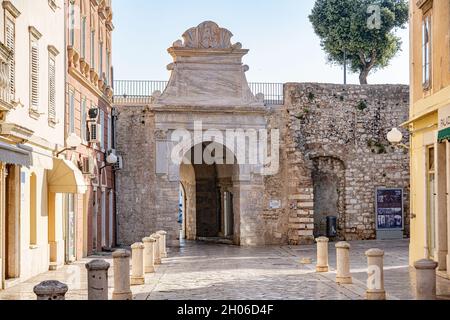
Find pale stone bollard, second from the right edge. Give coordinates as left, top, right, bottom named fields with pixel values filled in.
left=366, top=249, right=386, bottom=300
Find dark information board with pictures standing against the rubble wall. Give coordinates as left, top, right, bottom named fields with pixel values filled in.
left=375, top=188, right=405, bottom=240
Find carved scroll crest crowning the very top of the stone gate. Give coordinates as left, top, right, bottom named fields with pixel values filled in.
left=174, top=21, right=241, bottom=49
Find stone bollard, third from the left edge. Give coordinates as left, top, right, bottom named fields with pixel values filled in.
left=113, top=250, right=133, bottom=300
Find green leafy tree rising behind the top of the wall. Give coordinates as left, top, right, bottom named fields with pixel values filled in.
left=309, top=0, right=409, bottom=84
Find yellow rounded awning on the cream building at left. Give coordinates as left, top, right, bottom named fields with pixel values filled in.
left=47, top=159, right=87, bottom=194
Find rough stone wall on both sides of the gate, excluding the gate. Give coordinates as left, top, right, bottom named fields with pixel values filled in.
left=117, top=83, right=409, bottom=245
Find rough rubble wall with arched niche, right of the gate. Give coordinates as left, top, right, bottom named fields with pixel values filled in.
left=284, top=83, right=409, bottom=243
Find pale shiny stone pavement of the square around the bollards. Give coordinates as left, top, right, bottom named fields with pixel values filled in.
left=0, top=241, right=450, bottom=300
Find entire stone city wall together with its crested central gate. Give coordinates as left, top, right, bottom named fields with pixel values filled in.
left=115, top=21, right=409, bottom=246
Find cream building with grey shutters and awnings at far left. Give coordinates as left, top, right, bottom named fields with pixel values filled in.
left=0, top=0, right=75, bottom=288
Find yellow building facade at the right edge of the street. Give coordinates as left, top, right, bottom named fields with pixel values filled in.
left=405, top=0, right=450, bottom=275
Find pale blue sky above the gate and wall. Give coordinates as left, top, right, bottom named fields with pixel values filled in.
left=113, top=0, right=409, bottom=84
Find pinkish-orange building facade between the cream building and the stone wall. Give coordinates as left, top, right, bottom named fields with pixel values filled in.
left=65, top=0, right=115, bottom=259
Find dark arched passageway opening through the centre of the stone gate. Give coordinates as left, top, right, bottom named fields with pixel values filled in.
left=180, top=142, right=239, bottom=244
